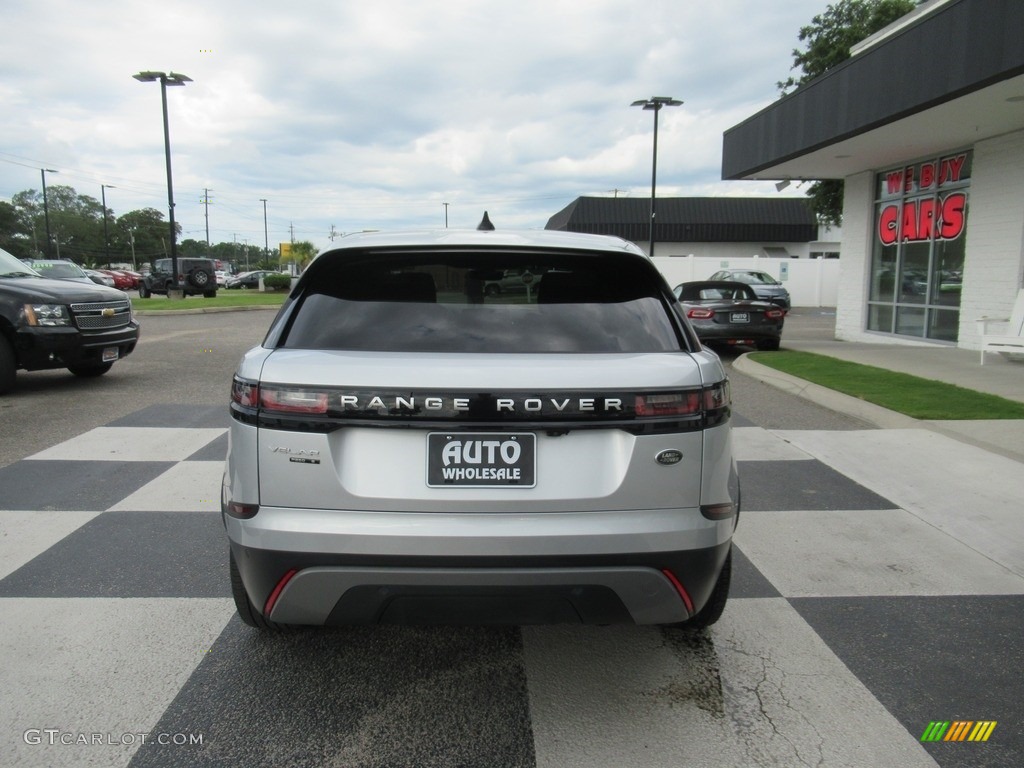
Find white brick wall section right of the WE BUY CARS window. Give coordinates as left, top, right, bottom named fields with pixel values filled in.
left=958, top=131, right=1024, bottom=349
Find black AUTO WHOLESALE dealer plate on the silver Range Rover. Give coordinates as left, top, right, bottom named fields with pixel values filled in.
left=427, top=432, right=537, bottom=488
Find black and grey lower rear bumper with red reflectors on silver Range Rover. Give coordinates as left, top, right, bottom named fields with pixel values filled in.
left=228, top=518, right=735, bottom=626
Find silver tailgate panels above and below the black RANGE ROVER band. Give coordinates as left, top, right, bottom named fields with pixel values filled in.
left=251, top=349, right=703, bottom=513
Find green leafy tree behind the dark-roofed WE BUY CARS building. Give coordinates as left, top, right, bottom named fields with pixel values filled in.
left=778, top=0, right=916, bottom=226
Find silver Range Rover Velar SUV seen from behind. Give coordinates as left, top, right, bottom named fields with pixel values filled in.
left=222, top=230, right=739, bottom=630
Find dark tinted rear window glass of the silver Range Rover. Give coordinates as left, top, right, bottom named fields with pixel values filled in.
left=279, top=252, right=681, bottom=353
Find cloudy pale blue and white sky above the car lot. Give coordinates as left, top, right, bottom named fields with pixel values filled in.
left=0, top=0, right=829, bottom=247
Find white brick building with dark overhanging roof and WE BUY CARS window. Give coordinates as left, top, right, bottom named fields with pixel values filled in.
left=722, top=0, right=1024, bottom=349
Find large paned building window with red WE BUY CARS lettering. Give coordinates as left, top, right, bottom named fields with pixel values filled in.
left=867, top=152, right=972, bottom=342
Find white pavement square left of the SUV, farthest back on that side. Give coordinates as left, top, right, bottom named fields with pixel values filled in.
left=29, top=427, right=227, bottom=462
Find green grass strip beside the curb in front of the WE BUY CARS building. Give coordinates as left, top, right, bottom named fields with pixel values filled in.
left=751, top=350, right=1024, bottom=421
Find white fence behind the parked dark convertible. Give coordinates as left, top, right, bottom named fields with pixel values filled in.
left=654, top=256, right=839, bottom=306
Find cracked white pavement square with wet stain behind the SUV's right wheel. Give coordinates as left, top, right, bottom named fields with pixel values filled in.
left=523, top=598, right=935, bottom=768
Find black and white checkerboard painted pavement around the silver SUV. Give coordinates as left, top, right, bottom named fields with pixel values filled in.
left=0, top=406, right=1024, bottom=768
